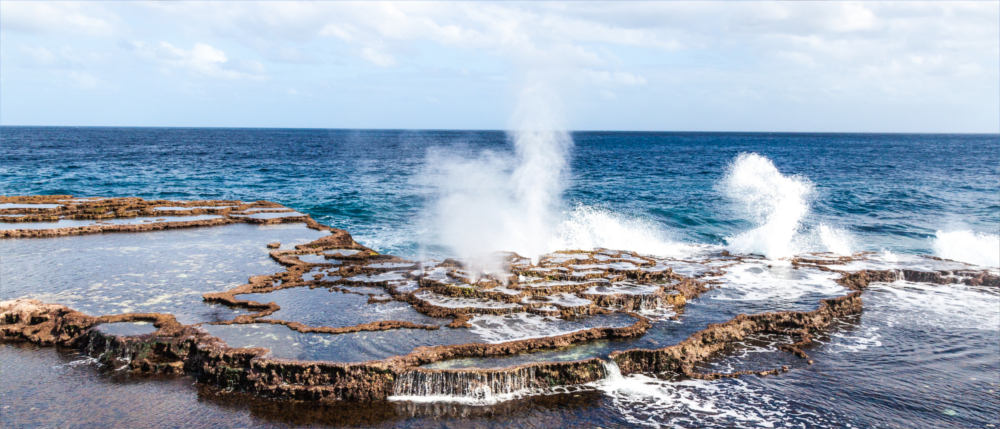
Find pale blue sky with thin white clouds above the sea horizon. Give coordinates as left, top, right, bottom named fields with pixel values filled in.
left=0, top=0, right=1000, bottom=133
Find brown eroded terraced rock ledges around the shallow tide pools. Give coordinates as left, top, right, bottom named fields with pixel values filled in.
left=0, top=196, right=1000, bottom=401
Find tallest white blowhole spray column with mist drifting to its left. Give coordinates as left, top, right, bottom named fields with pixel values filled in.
left=416, top=85, right=572, bottom=273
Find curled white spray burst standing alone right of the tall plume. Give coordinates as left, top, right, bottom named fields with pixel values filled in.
left=719, top=153, right=813, bottom=258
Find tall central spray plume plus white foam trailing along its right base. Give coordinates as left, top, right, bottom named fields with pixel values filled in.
left=422, top=85, right=697, bottom=273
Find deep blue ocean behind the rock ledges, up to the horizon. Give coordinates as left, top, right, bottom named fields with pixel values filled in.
left=0, top=123, right=1000, bottom=256
